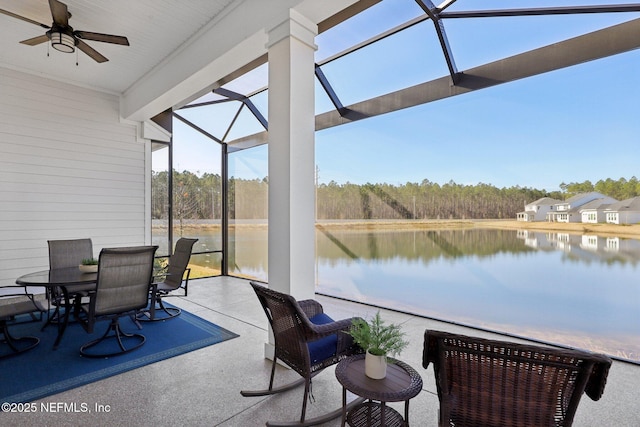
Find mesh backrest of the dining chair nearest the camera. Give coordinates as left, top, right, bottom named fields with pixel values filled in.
left=95, top=246, right=158, bottom=316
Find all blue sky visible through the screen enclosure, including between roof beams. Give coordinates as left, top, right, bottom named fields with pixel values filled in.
left=171, top=0, right=640, bottom=191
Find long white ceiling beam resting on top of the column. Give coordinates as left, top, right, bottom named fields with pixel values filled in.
left=121, top=0, right=380, bottom=121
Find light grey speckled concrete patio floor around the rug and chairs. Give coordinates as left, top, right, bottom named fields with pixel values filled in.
left=0, top=277, right=640, bottom=427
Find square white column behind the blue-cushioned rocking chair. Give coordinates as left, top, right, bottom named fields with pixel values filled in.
left=267, top=10, right=318, bottom=299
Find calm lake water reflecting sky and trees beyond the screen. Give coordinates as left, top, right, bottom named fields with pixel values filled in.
left=190, top=228, right=640, bottom=363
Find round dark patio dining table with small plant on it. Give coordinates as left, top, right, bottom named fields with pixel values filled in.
left=16, top=267, right=98, bottom=349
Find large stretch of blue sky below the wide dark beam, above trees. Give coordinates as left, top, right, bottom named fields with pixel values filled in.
left=316, top=52, right=640, bottom=191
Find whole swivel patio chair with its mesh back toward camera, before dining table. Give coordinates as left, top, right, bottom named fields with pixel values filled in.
left=80, top=246, right=158, bottom=357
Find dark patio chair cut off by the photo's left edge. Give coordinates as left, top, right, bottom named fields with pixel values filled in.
left=0, top=286, right=46, bottom=359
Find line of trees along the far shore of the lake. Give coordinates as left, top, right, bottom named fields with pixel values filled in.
left=152, top=171, right=640, bottom=221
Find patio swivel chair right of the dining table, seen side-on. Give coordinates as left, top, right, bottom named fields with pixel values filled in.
left=137, top=237, right=198, bottom=321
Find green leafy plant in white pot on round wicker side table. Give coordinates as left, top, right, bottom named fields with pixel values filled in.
left=349, top=311, right=409, bottom=379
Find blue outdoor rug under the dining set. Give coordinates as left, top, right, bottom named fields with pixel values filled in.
left=0, top=304, right=238, bottom=403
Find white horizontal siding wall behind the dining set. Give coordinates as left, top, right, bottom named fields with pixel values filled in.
left=0, top=67, right=145, bottom=285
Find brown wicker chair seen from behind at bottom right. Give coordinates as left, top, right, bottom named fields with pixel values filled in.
left=423, top=330, right=611, bottom=427
